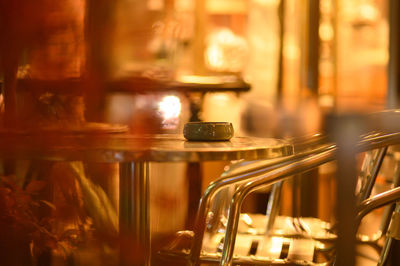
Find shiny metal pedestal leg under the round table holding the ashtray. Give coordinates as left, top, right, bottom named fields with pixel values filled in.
left=119, top=162, right=151, bottom=266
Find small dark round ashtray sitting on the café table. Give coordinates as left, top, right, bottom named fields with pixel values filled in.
left=183, top=122, right=233, bottom=141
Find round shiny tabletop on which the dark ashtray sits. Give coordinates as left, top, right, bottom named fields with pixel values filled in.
left=0, top=132, right=293, bottom=162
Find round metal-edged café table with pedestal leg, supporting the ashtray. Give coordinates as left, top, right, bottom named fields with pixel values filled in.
left=0, top=132, right=293, bottom=265
